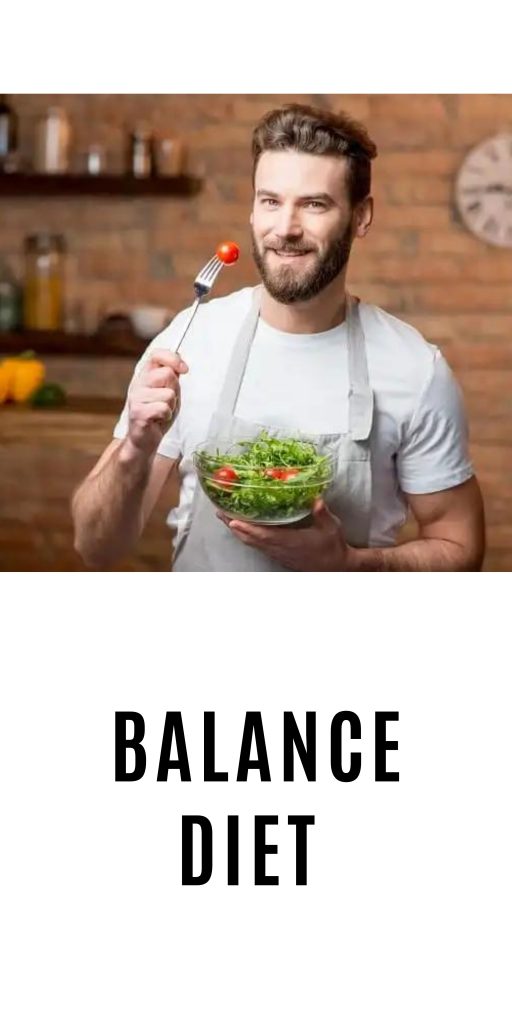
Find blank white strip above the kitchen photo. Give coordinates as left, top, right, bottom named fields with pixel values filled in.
left=1, top=0, right=512, bottom=96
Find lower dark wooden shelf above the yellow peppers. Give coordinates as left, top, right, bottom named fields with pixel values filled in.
left=0, top=331, right=148, bottom=358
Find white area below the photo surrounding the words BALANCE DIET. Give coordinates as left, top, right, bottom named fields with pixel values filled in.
left=0, top=573, right=511, bottom=1024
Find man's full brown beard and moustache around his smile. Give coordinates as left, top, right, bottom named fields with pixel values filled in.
left=251, top=224, right=352, bottom=305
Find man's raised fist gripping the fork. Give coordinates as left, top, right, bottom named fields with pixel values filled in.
left=127, top=348, right=188, bottom=456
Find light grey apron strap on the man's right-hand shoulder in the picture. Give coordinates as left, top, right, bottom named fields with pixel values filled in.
left=347, top=295, right=374, bottom=441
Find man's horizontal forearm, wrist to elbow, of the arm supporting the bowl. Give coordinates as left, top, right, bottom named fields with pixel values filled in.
left=350, top=538, right=483, bottom=572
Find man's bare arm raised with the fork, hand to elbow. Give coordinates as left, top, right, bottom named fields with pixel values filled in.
left=72, top=349, right=187, bottom=568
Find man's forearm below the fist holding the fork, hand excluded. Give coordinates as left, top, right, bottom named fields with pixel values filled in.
left=72, top=439, right=153, bottom=568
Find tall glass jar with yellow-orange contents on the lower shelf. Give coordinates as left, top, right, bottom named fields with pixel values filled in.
left=24, top=232, right=66, bottom=331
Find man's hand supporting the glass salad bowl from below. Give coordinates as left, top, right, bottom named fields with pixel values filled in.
left=217, top=500, right=355, bottom=572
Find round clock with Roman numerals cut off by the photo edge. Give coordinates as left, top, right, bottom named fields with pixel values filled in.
left=456, top=134, right=512, bottom=249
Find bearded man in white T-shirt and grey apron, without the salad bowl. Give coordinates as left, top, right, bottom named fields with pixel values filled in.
left=73, top=104, right=484, bottom=572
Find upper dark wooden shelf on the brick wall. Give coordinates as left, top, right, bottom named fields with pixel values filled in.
left=0, top=173, right=201, bottom=199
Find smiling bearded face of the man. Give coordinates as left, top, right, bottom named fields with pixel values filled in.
left=251, top=150, right=354, bottom=304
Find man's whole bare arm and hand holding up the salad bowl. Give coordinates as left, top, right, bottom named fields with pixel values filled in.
left=218, top=477, right=484, bottom=572
